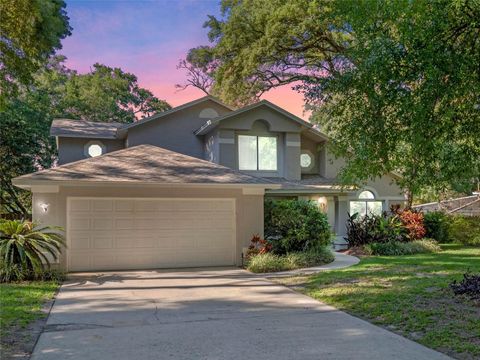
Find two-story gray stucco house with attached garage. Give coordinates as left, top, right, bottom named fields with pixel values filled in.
left=14, top=96, right=404, bottom=271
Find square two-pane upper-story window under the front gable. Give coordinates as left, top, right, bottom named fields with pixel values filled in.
left=238, top=135, right=277, bottom=171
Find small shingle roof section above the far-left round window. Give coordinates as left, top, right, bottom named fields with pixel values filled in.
left=50, top=119, right=124, bottom=139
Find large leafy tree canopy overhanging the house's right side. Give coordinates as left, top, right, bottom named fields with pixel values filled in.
left=180, top=0, right=480, bottom=202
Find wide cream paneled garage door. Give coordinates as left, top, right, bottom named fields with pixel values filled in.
left=67, top=198, right=235, bottom=271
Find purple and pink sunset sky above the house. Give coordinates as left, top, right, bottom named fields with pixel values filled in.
left=59, top=0, right=308, bottom=118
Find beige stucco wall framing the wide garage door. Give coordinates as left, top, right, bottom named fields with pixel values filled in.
left=32, top=185, right=263, bottom=267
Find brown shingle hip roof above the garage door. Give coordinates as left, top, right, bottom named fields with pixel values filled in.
left=14, top=145, right=279, bottom=188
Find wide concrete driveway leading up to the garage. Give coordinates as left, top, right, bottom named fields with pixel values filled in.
left=32, top=268, right=448, bottom=360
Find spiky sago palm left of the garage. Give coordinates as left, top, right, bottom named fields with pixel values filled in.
left=0, top=220, right=65, bottom=281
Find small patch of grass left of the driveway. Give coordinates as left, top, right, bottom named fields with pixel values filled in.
left=0, top=281, right=60, bottom=357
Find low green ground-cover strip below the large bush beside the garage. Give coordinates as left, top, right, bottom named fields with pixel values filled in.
left=247, top=248, right=335, bottom=273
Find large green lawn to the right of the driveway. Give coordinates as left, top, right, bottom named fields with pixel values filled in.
left=280, top=245, right=480, bottom=359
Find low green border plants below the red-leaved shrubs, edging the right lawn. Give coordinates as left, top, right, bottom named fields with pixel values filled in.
left=364, top=238, right=441, bottom=256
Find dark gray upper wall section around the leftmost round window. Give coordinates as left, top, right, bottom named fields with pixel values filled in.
left=58, top=137, right=125, bottom=165
